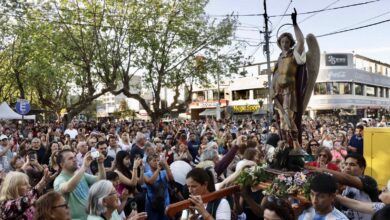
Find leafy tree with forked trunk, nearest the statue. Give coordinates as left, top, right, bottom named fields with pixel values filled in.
left=112, top=0, right=242, bottom=121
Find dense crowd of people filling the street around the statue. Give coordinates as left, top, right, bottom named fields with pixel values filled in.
left=0, top=117, right=390, bottom=220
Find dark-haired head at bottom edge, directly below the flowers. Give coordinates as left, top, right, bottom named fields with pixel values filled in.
left=262, top=196, right=295, bottom=220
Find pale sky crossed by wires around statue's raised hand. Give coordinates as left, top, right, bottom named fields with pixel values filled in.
left=206, top=0, right=390, bottom=64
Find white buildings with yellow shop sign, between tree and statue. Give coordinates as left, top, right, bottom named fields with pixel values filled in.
left=189, top=75, right=268, bottom=119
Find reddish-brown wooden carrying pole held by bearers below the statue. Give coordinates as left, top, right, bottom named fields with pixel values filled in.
left=165, top=185, right=240, bottom=218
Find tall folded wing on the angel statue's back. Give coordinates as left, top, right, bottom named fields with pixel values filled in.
left=303, top=34, right=321, bottom=111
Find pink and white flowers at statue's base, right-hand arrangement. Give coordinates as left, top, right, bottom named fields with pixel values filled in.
left=263, top=172, right=312, bottom=199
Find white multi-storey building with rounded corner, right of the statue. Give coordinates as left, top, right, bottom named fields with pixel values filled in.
left=307, top=53, right=390, bottom=118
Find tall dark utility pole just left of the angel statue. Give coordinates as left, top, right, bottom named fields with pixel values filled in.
left=263, top=0, right=273, bottom=126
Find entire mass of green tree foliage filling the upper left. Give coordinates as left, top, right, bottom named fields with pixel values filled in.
left=0, top=0, right=243, bottom=122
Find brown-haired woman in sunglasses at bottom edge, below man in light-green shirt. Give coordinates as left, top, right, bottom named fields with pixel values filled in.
left=34, top=191, right=70, bottom=220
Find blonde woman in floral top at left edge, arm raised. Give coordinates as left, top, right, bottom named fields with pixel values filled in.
left=0, top=169, right=50, bottom=220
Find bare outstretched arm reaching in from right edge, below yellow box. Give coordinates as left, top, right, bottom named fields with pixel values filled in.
left=336, top=180, right=390, bottom=214
